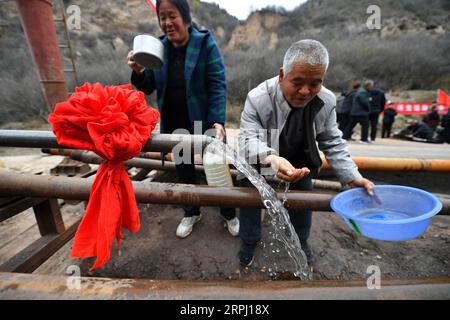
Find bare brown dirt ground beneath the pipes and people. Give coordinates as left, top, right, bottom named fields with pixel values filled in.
left=0, top=136, right=450, bottom=280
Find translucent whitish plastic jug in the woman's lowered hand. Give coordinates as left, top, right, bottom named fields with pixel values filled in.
left=203, top=149, right=233, bottom=187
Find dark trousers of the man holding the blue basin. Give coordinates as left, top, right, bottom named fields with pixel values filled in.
left=238, top=177, right=313, bottom=245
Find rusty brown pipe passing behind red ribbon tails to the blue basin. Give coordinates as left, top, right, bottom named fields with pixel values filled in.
left=0, top=171, right=333, bottom=211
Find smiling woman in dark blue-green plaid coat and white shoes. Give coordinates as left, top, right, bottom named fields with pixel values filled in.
left=128, top=0, right=239, bottom=238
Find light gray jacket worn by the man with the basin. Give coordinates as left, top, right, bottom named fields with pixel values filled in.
left=239, top=76, right=362, bottom=184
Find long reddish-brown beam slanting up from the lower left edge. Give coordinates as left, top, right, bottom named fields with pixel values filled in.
left=0, top=219, right=81, bottom=273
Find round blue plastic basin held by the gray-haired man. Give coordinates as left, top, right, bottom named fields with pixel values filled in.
left=330, top=185, right=442, bottom=241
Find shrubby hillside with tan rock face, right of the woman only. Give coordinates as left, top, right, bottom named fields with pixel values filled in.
left=224, top=0, right=450, bottom=100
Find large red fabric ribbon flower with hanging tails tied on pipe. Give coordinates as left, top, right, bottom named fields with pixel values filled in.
left=49, top=83, right=159, bottom=270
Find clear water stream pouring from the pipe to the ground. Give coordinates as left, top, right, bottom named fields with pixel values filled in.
left=205, top=140, right=312, bottom=280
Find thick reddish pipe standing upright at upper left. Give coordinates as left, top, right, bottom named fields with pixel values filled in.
left=16, top=0, right=67, bottom=112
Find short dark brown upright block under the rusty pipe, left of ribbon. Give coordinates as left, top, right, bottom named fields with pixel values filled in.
left=33, top=199, right=66, bottom=236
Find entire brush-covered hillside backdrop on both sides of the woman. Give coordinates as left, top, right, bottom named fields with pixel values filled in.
left=0, top=0, right=450, bottom=125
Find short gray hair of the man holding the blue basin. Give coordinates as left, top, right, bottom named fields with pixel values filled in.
left=283, top=39, right=330, bottom=74
